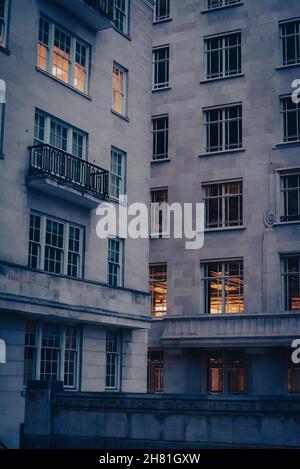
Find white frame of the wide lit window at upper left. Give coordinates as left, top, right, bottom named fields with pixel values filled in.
left=37, top=15, right=91, bottom=94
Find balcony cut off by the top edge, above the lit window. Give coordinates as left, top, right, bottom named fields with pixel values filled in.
left=54, top=0, right=114, bottom=31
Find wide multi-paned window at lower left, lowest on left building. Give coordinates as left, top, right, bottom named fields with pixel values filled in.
left=24, top=321, right=79, bottom=389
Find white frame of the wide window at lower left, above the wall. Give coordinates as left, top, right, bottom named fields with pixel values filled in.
left=24, top=320, right=81, bottom=390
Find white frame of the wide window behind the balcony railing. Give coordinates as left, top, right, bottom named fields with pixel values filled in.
left=34, top=109, right=88, bottom=160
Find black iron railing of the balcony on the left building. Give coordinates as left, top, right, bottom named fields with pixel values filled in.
left=29, top=144, right=109, bottom=197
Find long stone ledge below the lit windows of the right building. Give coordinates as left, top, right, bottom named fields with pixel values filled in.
left=162, top=313, right=300, bottom=348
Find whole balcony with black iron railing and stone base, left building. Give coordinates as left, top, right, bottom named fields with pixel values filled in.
left=27, top=144, right=109, bottom=209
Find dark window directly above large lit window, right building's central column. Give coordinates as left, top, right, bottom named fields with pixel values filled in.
left=204, top=181, right=243, bottom=229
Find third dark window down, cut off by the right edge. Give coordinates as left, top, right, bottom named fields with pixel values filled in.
left=281, top=173, right=300, bottom=222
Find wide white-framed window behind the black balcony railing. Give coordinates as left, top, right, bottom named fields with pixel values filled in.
left=34, top=110, right=87, bottom=159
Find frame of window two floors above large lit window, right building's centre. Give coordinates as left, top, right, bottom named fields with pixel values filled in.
left=203, top=103, right=243, bottom=155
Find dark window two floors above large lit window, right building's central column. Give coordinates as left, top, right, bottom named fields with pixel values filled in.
left=204, top=104, right=243, bottom=152
